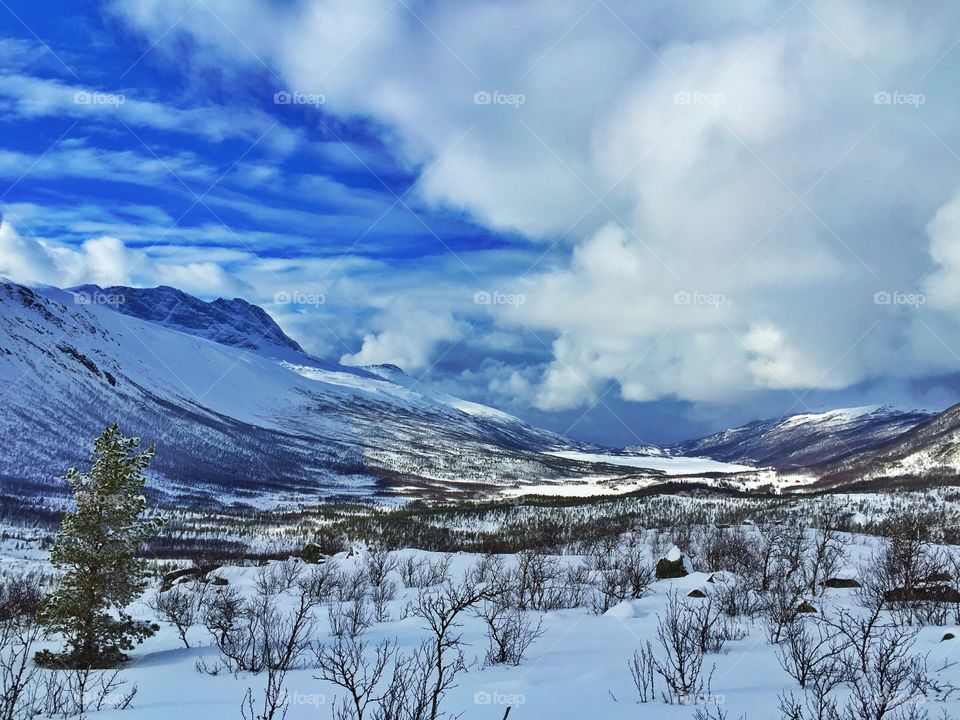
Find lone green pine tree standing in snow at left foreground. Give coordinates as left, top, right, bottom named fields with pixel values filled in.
left=37, top=424, right=162, bottom=668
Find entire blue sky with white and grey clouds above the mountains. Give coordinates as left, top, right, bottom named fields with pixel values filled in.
left=0, top=0, right=960, bottom=446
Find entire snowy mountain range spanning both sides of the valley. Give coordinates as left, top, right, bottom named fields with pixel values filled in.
left=0, top=281, right=960, bottom=508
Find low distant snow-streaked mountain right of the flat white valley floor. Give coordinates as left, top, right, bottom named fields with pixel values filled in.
left=668, top=406, right=932, bottom=469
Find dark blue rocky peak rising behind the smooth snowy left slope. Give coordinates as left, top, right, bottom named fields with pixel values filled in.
left=70, top=285, right=303, bottom=352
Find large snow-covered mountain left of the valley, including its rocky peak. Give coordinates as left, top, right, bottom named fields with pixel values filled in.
left=0, top=281, right=635, bottom=510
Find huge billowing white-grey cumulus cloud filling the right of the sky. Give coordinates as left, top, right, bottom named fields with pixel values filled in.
left=63, top=0, right=960, bottom=410
